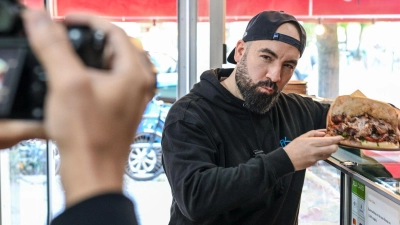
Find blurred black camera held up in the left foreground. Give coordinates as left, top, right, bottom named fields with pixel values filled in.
left=0, top=0, right=106, bottom=120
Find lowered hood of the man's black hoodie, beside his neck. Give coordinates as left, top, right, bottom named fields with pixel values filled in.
left=191, top=68, right=249, bottom=115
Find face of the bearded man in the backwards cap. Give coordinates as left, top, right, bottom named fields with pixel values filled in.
left=235, top=23, right=300, bottom=114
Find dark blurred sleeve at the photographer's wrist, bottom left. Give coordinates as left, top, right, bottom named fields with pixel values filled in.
left=51, top=193, right=138, bottom=225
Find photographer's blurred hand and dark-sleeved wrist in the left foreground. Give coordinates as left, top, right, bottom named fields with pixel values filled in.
left=0, top=10, right=155, bottom=225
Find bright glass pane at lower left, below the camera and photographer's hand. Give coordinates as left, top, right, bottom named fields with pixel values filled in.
left=1, top=139, right=47, bottom=225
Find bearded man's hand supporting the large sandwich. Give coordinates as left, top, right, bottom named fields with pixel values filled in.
left=284, top=129, right=343, bottom=171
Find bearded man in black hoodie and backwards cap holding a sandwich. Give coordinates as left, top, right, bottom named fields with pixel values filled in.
left=162, top=11, right=342, bottom=225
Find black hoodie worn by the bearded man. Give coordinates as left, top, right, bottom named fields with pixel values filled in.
left=162, top=69, right=328, bottom=225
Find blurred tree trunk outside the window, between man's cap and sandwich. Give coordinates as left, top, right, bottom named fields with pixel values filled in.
left=317, top=24, right=339, bottom=99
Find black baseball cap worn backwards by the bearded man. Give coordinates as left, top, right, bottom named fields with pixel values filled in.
left=228, top=11, right=306, bottom=64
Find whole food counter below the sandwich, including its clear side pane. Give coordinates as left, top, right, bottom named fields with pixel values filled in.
left=298, top=147, right=400, bottom=225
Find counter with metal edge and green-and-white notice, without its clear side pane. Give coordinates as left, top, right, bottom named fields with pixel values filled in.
left=325, top=147, right=400, bottom=225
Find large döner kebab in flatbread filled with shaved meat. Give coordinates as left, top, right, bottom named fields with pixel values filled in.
left=327, top=95, right=399, bottom=150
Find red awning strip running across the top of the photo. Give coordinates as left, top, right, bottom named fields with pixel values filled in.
left=23, top=0, right=400, bottom=21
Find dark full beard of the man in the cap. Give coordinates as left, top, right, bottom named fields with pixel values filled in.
left=235, top=52, right=281, bottom=114
